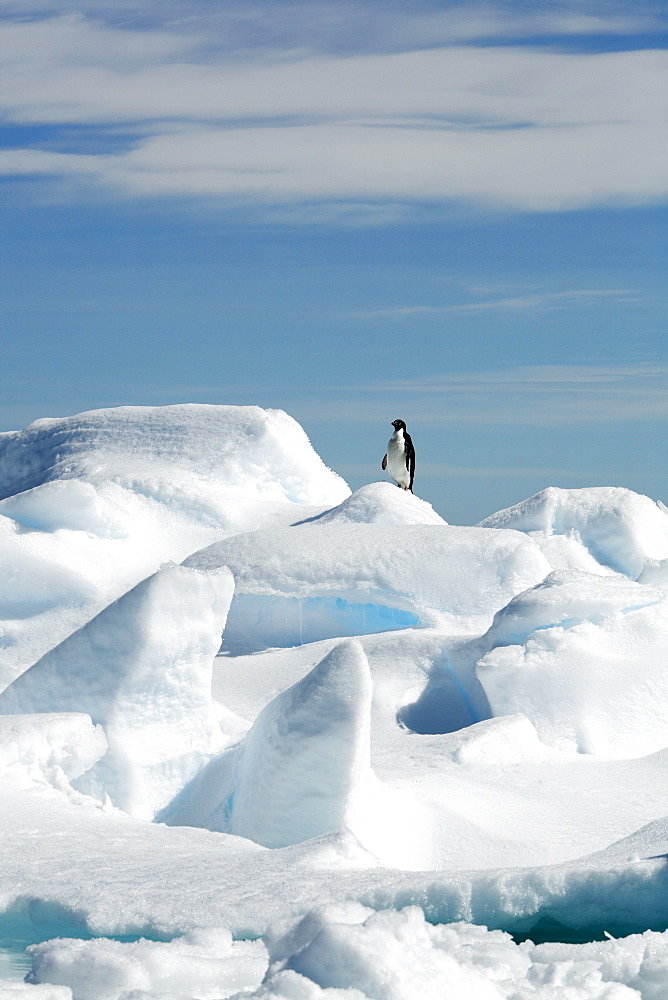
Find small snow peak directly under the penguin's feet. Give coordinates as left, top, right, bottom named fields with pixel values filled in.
left=302, top=483, right=447, bottom=524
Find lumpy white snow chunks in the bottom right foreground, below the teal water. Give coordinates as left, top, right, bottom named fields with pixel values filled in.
left=243, top=903, right=668, bottom=1000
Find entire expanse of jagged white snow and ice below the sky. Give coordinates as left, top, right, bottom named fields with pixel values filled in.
left=0, top=404, right=668, bottom=1000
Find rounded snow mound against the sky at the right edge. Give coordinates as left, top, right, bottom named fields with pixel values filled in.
left=480, top=486, right=668, bottom=580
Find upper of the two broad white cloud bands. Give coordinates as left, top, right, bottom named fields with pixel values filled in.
left=0, top=32, right=668, bottom=129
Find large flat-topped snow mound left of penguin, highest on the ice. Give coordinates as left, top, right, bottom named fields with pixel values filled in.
left=0, top=404, right=344, bottom=687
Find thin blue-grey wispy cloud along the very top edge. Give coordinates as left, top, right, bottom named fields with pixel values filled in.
left=0, top=0, right=665, bottom=52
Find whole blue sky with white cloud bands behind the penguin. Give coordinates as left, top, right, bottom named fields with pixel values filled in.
left=0, top=0, right=668, bottom=523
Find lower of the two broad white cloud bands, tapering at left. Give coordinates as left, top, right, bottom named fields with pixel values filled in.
left=0, top=116, right=668, bottom=211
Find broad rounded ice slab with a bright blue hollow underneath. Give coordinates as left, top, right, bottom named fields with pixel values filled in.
left=184, top=520, right=551, bottom=651
